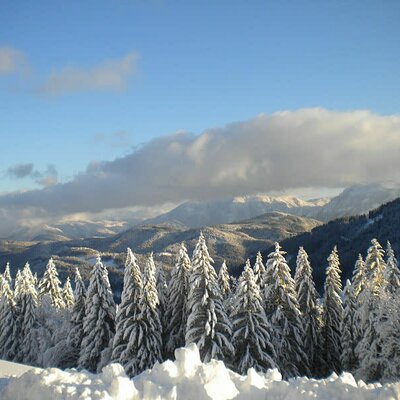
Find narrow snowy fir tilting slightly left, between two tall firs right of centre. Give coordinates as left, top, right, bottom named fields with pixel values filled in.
left=294, top=247, right=321, bottom=376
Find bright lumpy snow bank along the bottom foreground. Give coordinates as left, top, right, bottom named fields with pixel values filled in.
left=0, top=345, right=400, bottom=400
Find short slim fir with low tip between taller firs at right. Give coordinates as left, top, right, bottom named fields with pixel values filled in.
left=340, top=280, right=357, bottom=372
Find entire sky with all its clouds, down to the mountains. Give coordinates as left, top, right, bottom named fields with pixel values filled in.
left=0, top=0, right=400, bottom=233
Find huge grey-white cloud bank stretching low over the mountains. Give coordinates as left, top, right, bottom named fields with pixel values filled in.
left=0, top=109, right=400, bottom=230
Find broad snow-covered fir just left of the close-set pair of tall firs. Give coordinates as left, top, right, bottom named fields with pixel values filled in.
left=78, top=257, right=115, bottom=372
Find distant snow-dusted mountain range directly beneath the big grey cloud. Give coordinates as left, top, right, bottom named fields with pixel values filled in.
left=6, top=184, right=400, bottom=241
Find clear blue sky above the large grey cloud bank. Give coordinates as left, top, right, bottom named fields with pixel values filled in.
left=0, top=0, right=400, bottom=197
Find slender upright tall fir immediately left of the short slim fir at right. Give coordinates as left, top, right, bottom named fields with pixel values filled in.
left=321, top=246, right=343, bottom=373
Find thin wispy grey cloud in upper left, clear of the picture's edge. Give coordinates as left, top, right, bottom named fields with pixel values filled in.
left=39, top=52, right=138, bottom=96
